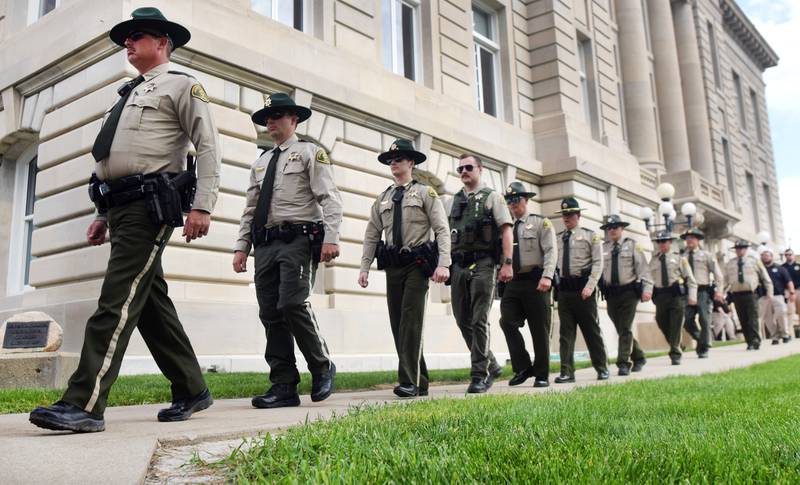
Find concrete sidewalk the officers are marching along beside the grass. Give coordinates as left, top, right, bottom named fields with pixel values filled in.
left=0, top=339, right=800, bottom=485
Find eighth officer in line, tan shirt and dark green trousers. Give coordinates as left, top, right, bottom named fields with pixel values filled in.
left=650, top=231, right=697, bottom=365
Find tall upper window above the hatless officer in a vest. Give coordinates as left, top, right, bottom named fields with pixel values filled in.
left=472, top=5, right=500, bottom=116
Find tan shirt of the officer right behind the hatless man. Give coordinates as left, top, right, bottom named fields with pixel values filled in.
left=514, top=214, right=558, bottom=279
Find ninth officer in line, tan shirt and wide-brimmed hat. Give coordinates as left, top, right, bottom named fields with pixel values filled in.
left=681, top=227, right=724, bottom=359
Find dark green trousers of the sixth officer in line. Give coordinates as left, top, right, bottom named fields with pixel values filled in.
left=558, top=290, right=608, bottom=376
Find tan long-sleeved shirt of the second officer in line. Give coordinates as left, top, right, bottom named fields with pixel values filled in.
left=235, top=135, right=342, bottom=253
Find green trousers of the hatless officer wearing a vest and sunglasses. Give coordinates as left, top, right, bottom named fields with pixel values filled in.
left=450, top=258, right=500, bottom=379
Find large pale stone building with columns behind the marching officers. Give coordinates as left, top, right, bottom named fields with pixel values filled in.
left=0, top=0, right=783, bottom=372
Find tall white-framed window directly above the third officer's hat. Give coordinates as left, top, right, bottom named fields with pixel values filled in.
left=383, top=0, right=420, bottom=81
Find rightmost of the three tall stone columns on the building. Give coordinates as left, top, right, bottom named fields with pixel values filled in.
left=672, top=0, right=714, bottom=181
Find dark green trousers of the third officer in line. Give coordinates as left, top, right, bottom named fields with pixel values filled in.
left=386, top=263, right=428, bottom=389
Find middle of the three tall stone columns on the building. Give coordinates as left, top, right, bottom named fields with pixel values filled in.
left=647, top=0, right=692, bottom=173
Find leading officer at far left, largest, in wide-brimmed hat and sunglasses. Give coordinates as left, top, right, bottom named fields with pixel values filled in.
left=30, top=8, right=220, bottom=432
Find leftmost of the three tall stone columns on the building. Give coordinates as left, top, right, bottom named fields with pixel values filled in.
left=615, top=0, right=664, bottom=170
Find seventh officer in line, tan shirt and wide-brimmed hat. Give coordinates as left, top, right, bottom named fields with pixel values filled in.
left=600, top=214, right=653, bottom=376
